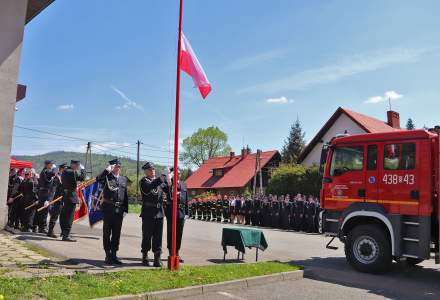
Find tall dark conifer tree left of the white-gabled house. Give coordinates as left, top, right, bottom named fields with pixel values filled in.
left=281, top=119, right=306, bottom=163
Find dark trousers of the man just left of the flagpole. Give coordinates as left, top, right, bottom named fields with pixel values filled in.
left=141, top=217, right=163, bottom=253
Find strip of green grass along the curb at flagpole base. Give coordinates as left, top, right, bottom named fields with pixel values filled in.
left=0, top=262, right=299, bottom=300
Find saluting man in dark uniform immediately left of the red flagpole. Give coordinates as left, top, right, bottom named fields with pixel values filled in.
left=139, top=162, right=169, bottom=267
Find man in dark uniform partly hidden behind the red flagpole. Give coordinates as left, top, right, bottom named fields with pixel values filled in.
left=164, top=168, right=188, bottom=263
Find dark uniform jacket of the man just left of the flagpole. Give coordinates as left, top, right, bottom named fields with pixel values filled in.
left=139, top=177, right=166, bottom=219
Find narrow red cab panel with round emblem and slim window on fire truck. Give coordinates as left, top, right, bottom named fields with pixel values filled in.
left=365, top=144, right=380, bottom=203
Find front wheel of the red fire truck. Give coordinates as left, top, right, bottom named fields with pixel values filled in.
left=345, top=224, right=392, bottom=273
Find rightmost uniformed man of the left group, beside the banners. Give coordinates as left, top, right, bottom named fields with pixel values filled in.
left=60, top=160, right=86, bottom=242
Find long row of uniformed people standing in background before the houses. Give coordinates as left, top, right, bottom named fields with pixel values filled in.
left=189, top=194, right=321, bottom=232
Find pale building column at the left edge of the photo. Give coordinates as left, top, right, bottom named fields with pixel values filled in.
left=0, top=0, right=28, bottom=229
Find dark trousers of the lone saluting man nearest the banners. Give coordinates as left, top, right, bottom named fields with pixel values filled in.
left=102, top=209, right=124, bottom=252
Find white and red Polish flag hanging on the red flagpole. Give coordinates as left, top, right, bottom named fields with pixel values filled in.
left=180, top=32, right=211, bottom=99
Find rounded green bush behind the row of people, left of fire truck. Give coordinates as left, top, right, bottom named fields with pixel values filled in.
left=267, top=164, right=321, bottom=197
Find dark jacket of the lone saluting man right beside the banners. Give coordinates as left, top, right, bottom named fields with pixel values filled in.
left=96, top=170, right=128, bottom=214
